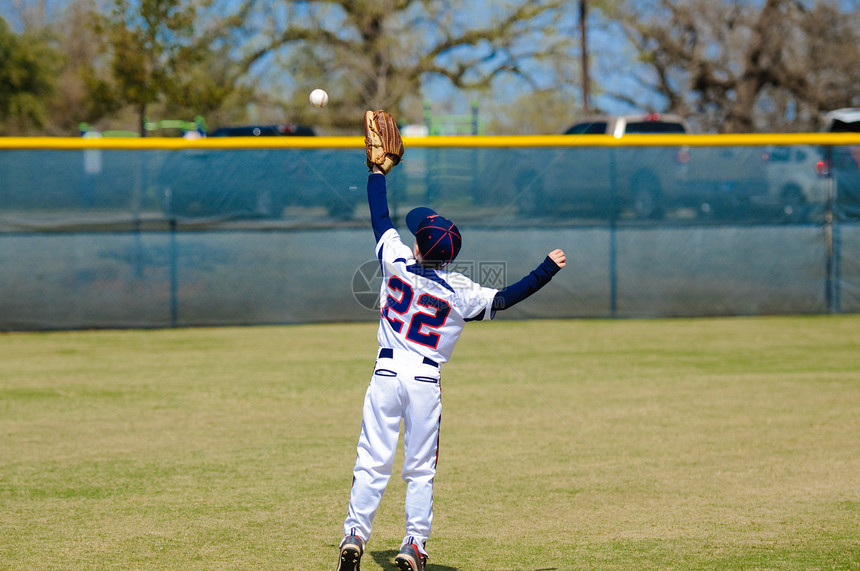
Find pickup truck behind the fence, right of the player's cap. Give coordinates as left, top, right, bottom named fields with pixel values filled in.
left=518, top=113, right=766, bottom=219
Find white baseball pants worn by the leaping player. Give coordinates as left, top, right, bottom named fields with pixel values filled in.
left=343, top=351, right=442, bottom=555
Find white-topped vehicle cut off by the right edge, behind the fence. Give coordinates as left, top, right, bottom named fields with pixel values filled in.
left=823, top=107, right=860, bottom=220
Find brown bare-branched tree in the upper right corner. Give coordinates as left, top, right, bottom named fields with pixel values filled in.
left=613, top=0, right=860, bottom=132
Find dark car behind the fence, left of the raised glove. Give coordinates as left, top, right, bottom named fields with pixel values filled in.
left=159, top=124, right=363, bottom=219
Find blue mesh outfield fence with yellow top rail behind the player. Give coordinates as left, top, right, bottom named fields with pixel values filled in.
left=0, top=134, right=860, bottom=330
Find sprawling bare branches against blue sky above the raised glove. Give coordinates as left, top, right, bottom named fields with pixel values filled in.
left=228, top=0, right=572, bottom=124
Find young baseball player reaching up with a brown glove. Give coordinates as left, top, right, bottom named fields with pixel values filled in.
left=337, top=111, right=566, bottom=571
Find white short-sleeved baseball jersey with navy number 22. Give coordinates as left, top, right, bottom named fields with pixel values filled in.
left=376, top=228, right=498, bottom=363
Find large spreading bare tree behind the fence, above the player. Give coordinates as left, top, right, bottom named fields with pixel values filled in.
left=225, top=0, right=577, bottom=129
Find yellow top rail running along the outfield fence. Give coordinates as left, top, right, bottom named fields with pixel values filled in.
left=0, top=133, right=860, bottom=151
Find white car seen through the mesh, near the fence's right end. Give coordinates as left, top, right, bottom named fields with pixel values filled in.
left=753, top=145, right=827, bottom=221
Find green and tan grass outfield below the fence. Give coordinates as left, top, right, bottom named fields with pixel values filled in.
left=0, top=316, right=860, bottom=571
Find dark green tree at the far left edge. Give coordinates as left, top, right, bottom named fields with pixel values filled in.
left=0, top=18, right=57, bottom=135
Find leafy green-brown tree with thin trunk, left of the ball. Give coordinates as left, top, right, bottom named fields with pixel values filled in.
left=88, top=0, right=253, bottom=135
